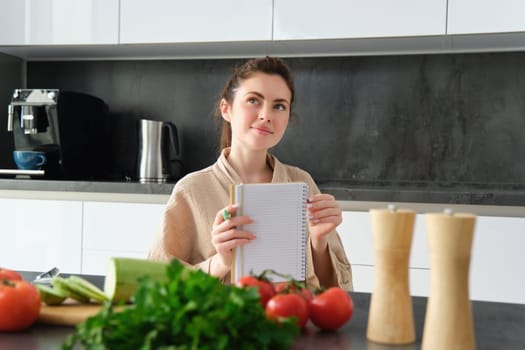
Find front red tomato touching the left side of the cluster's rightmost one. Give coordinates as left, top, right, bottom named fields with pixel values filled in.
left=265, top=294, right=308, bottom=328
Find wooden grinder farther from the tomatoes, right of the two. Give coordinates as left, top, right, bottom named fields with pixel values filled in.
left=421, top=209, right=476, bottom=350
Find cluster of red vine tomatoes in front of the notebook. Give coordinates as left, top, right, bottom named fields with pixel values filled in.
left=236, top=271, right=354, bottom=331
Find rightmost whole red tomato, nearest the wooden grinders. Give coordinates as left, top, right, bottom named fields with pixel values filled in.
left=309, top=287, right=354, bottom=331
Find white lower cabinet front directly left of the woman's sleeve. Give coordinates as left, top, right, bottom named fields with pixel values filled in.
left=82, top=202, right=165, bottom=275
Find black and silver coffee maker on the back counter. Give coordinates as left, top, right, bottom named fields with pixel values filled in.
left=7, top=89, right=110, bottom=180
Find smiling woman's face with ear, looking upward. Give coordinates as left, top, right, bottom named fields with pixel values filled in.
left=221, top=73, right=291, bottom=151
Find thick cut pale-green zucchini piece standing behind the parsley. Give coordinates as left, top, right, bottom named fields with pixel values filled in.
left=104, top=258, right=167, bottom=303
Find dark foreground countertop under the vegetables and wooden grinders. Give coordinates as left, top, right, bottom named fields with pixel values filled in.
left=4, top=272, right=525, bottom=350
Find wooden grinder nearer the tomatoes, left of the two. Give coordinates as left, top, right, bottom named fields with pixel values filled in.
left=366, top=206, right=416, bottom=344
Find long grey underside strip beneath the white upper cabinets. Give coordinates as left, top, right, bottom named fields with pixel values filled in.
left=0, top=32, right=525, bottom=61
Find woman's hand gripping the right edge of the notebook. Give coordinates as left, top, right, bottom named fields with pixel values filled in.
left=306, top=194, right=343, bottom=241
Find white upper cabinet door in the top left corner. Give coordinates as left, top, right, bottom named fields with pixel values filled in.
left=0, top=0, right=119, bottom=45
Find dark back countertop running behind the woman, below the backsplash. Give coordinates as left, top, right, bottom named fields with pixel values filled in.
left=0, top=178, right=525, bottom=207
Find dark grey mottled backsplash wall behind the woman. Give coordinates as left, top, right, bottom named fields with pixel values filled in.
left=7, top=52, right=525, bottom=187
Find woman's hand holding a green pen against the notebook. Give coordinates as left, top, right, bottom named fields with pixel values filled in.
left=211, top=205, right=255, bottom=277
